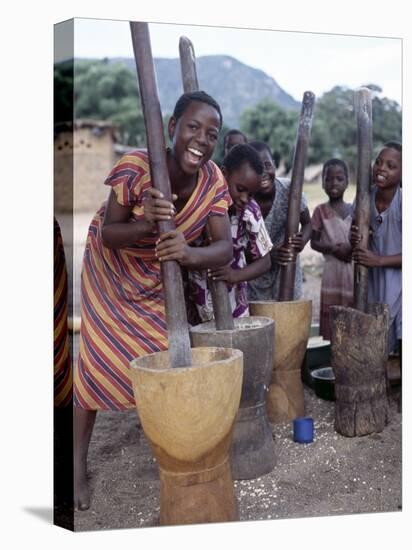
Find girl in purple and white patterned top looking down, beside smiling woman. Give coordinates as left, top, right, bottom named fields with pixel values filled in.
left=190, top=145, right=272, bottom=321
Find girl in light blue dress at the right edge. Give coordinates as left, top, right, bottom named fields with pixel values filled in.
left=351, top=141, right=402, bottom=353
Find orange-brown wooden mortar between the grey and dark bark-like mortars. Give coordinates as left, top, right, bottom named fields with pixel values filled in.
left=249, top=300, right=312, bottom=423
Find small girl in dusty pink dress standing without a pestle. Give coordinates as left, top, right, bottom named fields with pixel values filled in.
left=310, top=158, right=353, bottom=340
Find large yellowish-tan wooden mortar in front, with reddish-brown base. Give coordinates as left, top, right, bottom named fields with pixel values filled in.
left=130, top=347, right=243, bottom=525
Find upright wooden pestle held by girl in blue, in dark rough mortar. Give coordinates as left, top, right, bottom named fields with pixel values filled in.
left=354, top=88, right=372, bottom=311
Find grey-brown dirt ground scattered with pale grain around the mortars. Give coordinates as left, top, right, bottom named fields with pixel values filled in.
left=68, top=252, right=402, bottom=531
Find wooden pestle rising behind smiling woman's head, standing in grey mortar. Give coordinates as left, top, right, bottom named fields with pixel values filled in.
left=179, top=36, right=235, bottom=330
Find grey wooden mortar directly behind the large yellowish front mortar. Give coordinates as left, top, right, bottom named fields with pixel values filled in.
left=190, top=317, right=275, bottom=479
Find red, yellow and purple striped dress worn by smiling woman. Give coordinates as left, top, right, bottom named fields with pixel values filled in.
left=74, top=150, right=230, bottom=410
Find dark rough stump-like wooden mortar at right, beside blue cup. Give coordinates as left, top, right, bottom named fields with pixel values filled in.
left=330, top=304, right=389, bottom=437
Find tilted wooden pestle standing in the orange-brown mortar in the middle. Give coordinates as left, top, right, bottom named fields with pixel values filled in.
left=279, top=92, right=315, bottom=302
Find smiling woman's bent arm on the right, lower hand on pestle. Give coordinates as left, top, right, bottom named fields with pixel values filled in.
left=156, top=215, right=233, bottom=270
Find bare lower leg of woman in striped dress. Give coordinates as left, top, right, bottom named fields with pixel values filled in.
left=74, top=407, right=97, bottom=510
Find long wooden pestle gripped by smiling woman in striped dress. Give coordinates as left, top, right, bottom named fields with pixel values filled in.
left=130, top=22, right=192, bottom=374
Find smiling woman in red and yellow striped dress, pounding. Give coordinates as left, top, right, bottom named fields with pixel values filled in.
left=74, top=92, right=232, bottom=510
